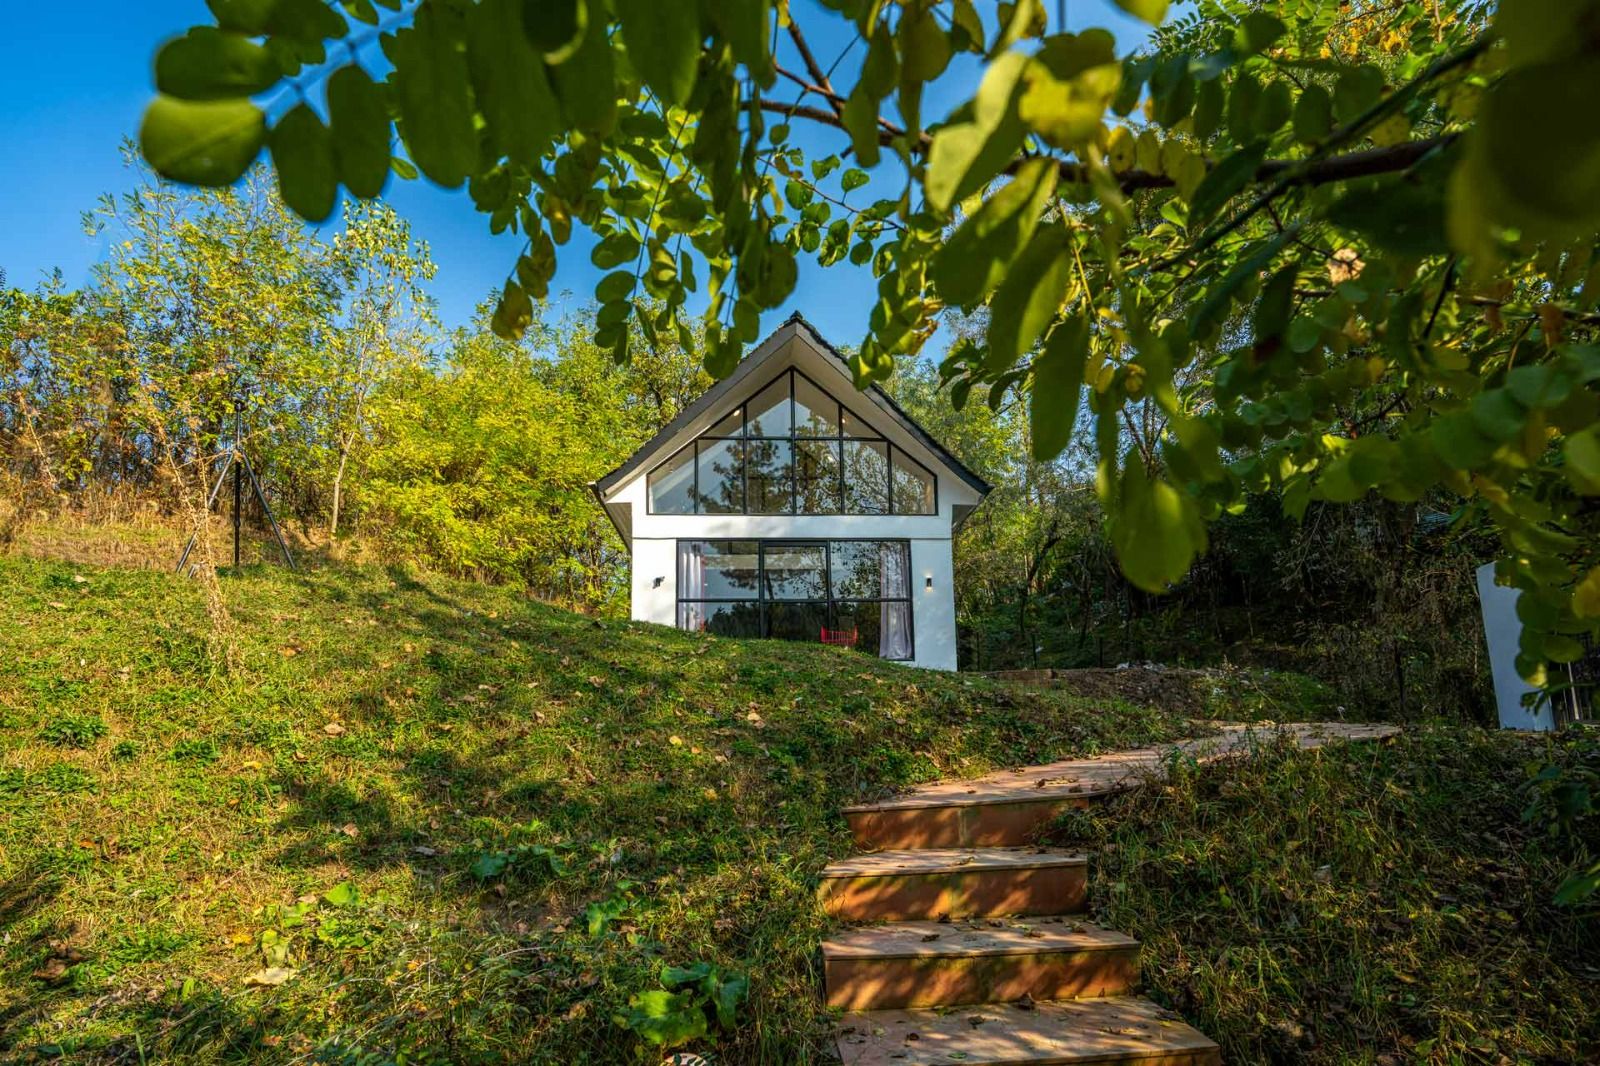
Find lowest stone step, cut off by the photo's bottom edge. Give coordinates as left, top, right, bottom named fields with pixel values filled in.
left=837, top=996, right=1222, bottom=1066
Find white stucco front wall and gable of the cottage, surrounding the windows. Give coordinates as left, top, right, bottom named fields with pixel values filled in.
left=605, top=332, right=982, bottom=671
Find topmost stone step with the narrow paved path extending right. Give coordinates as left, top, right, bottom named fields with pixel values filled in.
left=845, top=722, right=1398, bottom=848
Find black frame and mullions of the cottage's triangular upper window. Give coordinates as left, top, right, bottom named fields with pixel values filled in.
left=645, top=367, right=939, bottom=519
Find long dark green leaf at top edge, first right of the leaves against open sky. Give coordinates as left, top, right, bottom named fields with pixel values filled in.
left=389, top=3, right=478, bottom=189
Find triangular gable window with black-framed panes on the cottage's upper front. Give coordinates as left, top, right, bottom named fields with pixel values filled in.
left=648, top=370, right=939, bottom=514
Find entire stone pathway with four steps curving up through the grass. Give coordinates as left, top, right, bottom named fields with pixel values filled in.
left=821, top=722, right=1398, bottom=1066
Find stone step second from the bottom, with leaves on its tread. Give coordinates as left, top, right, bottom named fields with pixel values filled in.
left=822, top=916, right=1139, bottom=1010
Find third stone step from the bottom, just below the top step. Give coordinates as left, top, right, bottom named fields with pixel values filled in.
left=821, top=848, right=1088, bottom=922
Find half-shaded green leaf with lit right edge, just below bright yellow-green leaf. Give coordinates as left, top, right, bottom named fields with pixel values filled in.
left=928, top=158, right=1061, bottom=309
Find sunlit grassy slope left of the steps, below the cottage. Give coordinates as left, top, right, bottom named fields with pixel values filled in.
left=0, top=559, right=1192, bottom=1066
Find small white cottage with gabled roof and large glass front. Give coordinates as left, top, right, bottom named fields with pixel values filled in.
left=594, top=314, right=989, bottom=671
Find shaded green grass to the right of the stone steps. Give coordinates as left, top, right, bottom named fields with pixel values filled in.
left=1051, top=725, right=1600, bottom=1066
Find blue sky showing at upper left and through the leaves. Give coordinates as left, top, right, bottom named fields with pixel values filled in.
left=0, top=0, right=1144, bottom=344
